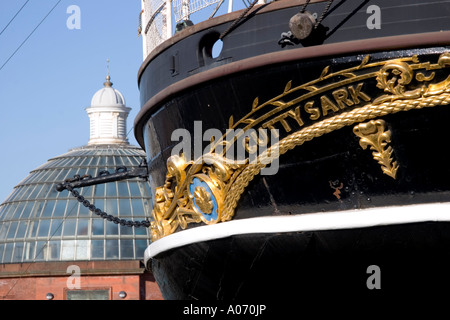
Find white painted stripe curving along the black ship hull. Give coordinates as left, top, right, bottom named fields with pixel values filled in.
left=144, top=202, right=450, bottom=263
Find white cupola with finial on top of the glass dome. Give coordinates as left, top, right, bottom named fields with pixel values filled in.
left=86, top=74, right=131, bottom=145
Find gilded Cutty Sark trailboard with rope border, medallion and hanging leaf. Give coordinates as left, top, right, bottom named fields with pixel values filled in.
left=152, top=53, right=450, bottom=241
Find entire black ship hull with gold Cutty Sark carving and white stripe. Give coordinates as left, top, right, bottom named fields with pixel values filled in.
left=135, top=1, right=450, bottom=300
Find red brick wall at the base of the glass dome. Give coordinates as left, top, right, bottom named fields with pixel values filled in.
left=0, top=261, right=162, bottom=300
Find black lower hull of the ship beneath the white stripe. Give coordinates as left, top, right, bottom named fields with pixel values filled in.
left=151, top=222, right=450, bottom=302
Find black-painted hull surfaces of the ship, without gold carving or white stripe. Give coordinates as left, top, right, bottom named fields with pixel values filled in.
left=135, top=0, right=450, bottom=300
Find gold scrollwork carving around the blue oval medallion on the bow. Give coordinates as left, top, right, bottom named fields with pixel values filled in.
left=151, top=154, right=236, bottom=241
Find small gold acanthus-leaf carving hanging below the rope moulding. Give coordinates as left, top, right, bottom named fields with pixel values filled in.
left=353, top=119, right=398, bottom=179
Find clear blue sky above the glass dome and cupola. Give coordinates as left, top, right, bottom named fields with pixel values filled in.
left=0, top=0, right=142, bottom=203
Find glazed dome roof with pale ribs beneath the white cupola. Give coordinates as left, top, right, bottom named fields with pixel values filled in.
left=0, top=145, right=151, bottom=263
